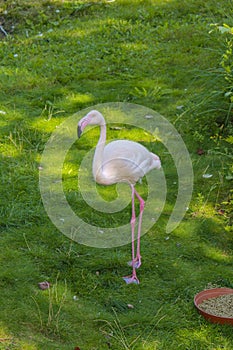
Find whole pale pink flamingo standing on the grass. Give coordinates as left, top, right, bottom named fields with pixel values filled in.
left=77, top=110, right=161, bottom=284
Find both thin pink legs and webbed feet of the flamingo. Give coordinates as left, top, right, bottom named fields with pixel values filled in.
left=123, top=185, right=144, bottom=284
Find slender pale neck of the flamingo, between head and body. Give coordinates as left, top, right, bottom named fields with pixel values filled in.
left=92, top=123, right=106, bottom=180
